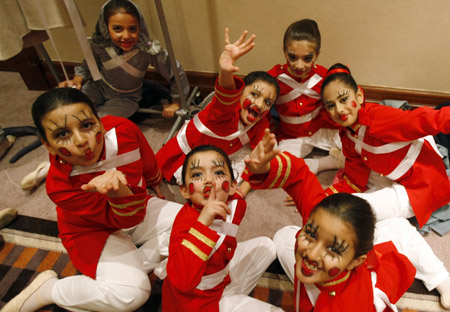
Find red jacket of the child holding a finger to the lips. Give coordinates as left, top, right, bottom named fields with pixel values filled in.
left=162, top=194, right=247, bottom=312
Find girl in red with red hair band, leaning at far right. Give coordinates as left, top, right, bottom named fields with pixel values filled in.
left=322, top=64, right=450, bottom=226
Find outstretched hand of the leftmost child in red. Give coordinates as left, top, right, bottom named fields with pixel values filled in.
left=81, top=170, right=133, bottom=197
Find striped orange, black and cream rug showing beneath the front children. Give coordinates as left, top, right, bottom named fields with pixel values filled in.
left=0, top=216, right=444, bottom=312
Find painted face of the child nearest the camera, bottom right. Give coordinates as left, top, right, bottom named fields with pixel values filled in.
left=295, top=208, right=360, bottom=284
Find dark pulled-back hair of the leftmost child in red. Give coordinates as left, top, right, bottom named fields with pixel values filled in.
left=31, top=88, right=98, bottom=141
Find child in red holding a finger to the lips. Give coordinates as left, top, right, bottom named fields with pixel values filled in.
left=162, top=145, right=282, bottom=312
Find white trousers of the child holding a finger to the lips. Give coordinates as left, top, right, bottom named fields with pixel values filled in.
left=219, top=236, right=283, bottom=312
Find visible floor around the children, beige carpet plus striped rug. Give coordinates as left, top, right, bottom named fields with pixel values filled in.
left=0, top=71, right=450, bottom=312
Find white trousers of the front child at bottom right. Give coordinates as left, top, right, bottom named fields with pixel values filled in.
left=273, top=218, right=449, bottom=290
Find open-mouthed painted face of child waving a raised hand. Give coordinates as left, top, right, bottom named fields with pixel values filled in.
left=240, top=80, right=277, bottom=126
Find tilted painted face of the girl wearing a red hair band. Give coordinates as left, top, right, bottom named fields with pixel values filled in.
left=322, top=80, right=364, bottom=127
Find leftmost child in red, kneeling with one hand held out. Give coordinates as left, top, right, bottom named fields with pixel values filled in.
left=2, top=88, right=181, bottom=312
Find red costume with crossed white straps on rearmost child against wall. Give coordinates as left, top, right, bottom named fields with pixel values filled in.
left=268, top=64, right=338, bottom=141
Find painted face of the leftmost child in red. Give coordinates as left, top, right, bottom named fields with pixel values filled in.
left=42, top=103, right=105, bottom=166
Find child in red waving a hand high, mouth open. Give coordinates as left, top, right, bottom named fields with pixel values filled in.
left=156, top=29, right=279, bottom=193
